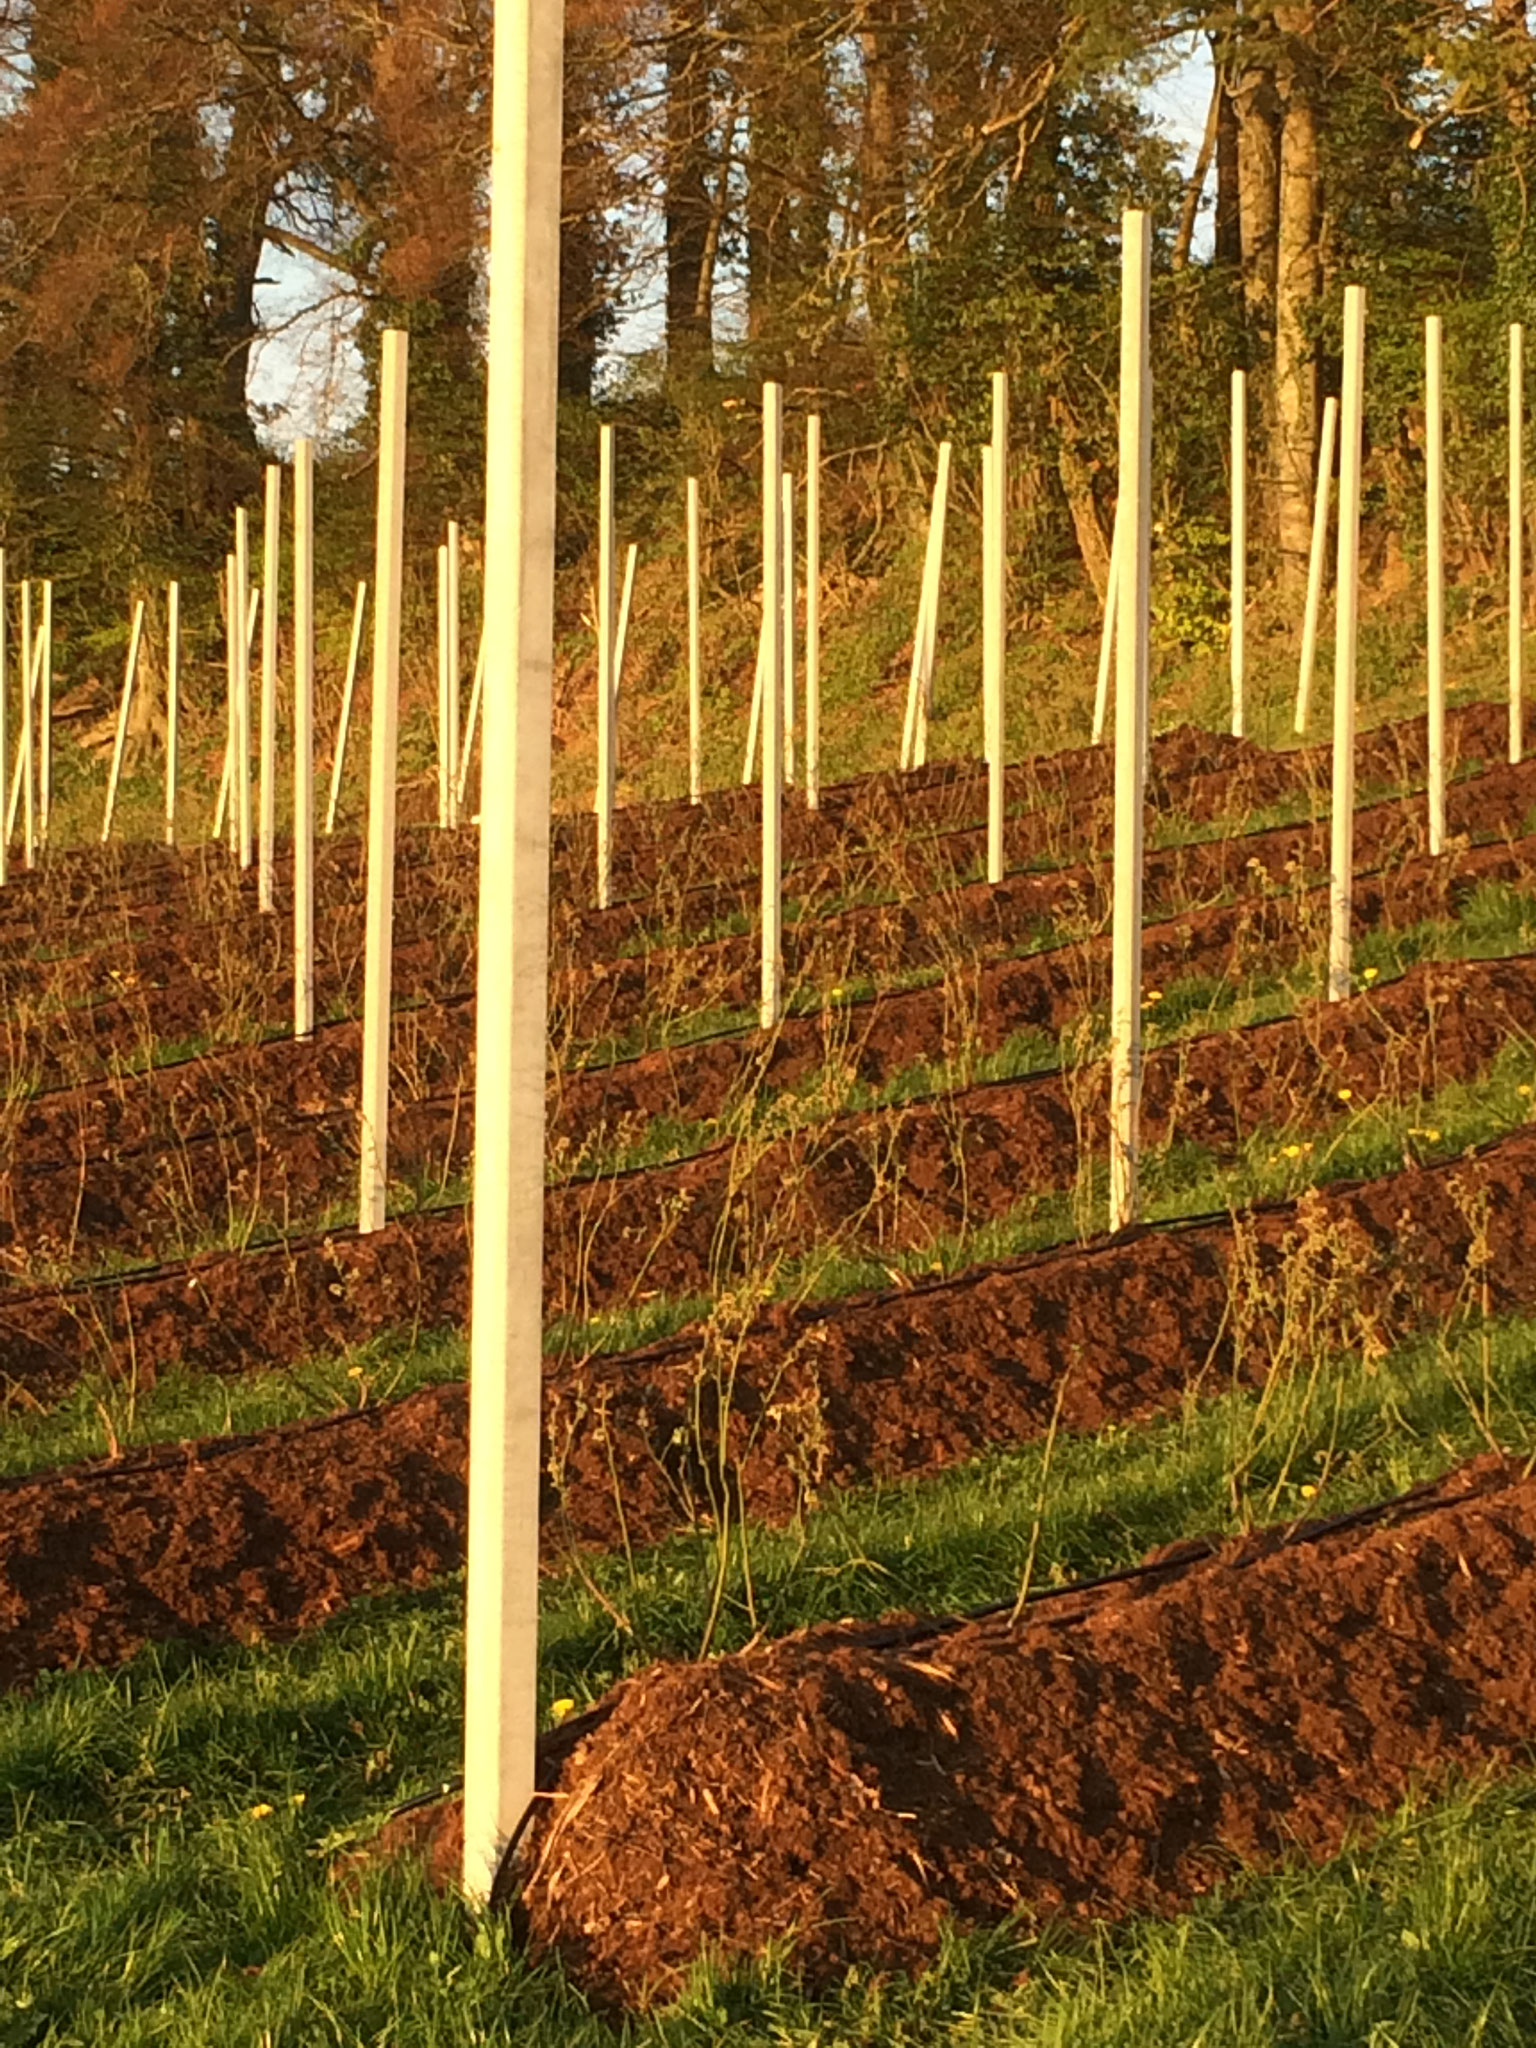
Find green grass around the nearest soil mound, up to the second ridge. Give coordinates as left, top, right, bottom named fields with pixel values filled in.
left=0, top=1286, right=1536, bottom=2048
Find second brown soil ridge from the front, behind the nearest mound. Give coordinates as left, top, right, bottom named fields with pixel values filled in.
left=0, top=1130, right=1536, bottom=1683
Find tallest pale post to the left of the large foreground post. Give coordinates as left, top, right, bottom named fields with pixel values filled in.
left=356, top=328, right=410, bottom=1233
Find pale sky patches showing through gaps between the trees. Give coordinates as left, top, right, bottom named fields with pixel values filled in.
left=248, top=35, right=1210, bottom=455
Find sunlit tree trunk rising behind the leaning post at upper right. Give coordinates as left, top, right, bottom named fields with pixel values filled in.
left=1270, top=8, right=1323, bottom=592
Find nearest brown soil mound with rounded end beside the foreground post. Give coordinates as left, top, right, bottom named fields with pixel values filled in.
left=507, top=1456, right=1536, bottom=2005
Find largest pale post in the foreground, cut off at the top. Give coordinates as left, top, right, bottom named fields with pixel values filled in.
left=463, top=0, right=561, bottom=1903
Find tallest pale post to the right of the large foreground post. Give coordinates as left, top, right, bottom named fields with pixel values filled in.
left=1110, top=211, right=1153, bottom=1231
